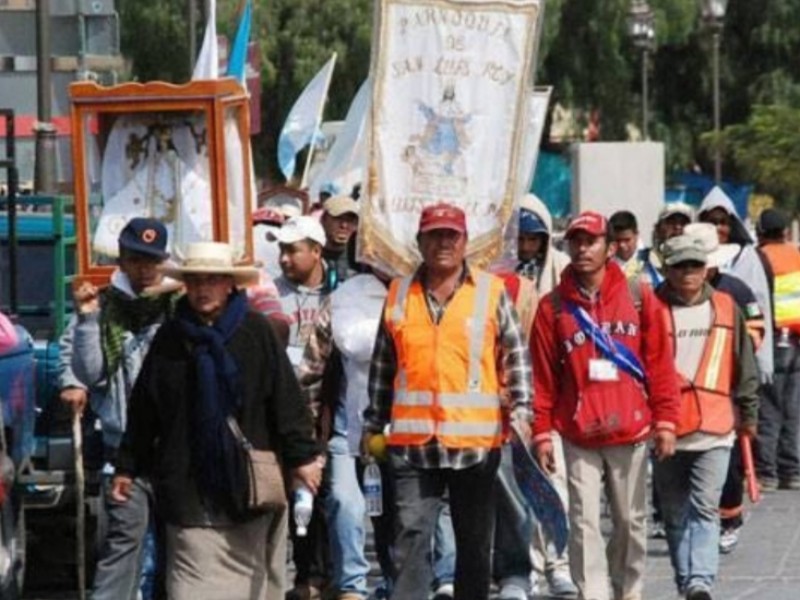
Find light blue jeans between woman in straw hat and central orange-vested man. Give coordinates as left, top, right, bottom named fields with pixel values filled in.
left=323, top=435, right=370, bottom=598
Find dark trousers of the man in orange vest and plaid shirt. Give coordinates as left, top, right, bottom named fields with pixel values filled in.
left=390, top=450, right=500, bottom=600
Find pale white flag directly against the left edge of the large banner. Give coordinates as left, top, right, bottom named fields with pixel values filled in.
left=309, top=79, right=372, bottom=199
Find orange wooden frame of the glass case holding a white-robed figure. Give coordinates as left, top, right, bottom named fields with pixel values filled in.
left=69, top=79, right=253, bottom=285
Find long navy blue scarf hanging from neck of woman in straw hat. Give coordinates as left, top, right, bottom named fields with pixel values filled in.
left=176, top=292, right=247, bottom=514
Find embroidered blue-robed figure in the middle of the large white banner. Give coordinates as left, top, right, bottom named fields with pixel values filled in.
left=403, top=84, right=472, bottom=195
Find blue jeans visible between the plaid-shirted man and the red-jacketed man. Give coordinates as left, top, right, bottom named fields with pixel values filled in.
left=493, top=444, right=535, bottom=591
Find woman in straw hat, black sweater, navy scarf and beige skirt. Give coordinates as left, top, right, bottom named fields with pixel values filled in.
left=113, top=242, right=322, bottom=600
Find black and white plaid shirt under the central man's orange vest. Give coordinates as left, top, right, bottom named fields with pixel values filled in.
left=364, top=268, right=533, bottom=469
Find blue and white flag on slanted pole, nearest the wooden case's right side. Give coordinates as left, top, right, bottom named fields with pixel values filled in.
left=278, top=54, right=336, bottom=181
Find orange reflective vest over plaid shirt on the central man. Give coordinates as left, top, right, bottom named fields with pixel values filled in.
left=384, top=270, right=504, bottom=448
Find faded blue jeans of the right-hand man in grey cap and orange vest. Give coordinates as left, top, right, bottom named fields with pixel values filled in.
left=655, top=446, right=731, bottom=592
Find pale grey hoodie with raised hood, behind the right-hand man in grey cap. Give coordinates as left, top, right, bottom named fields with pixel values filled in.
left=698, top=187, right=774, bottom=382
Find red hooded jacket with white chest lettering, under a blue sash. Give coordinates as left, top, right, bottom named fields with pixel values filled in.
left=530, top=261, right=680, bottom=447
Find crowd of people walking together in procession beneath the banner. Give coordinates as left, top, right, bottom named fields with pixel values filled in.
left=51, top=188, right=800, bottom=600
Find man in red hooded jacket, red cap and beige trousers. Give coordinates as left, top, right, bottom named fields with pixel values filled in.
left=531, top=212, right=679, bottom=600
